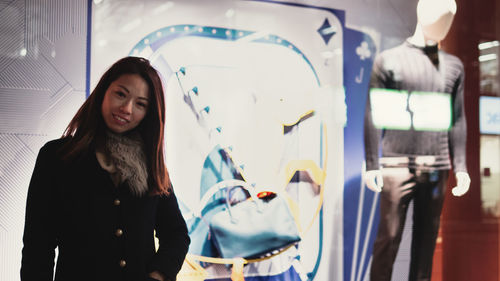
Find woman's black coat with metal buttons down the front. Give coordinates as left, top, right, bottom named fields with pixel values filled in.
left=21, top=139, right=190, bottom=281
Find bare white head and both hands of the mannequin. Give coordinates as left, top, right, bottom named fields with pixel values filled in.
left=365, top=0, right=470, bottom=196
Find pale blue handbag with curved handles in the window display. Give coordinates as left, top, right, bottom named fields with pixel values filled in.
left=209, top=181, right=300, bottom=259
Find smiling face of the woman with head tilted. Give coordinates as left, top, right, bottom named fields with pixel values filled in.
left=101, top=74, right=149, bottom=134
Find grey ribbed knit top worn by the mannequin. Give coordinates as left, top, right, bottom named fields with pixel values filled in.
left=364, top=41, right=467, bottom=172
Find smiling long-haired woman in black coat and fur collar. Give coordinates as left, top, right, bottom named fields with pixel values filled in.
left=21, top=57, right=190, bottom=281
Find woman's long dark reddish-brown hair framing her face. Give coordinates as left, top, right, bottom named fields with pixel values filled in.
left=61, top=57, right=172, bottom=195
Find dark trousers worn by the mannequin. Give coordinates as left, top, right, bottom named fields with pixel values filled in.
left=370, top=168, right=449, bottom=281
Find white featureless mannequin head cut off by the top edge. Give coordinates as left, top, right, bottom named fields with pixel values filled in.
left=410, top=0, right=457, bottom=46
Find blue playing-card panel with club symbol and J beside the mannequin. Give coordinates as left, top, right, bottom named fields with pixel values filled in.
left=344, top=26, right=378, bottom=281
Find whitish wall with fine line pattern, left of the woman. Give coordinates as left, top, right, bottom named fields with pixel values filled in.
left=0, top=0, right=87, bottom=281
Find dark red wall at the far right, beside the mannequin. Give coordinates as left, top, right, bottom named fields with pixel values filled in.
left=433, top=0, right=500, bottom=281
